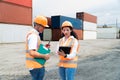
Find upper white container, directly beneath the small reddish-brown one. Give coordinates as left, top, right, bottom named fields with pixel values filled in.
left=83, top=21, right=97, bottom=31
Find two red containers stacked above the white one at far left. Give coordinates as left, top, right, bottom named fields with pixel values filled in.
left=0, top=0, right=32, bottom=25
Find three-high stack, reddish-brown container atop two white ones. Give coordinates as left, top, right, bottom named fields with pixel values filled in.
left=76, top=12, right=97, bottom=40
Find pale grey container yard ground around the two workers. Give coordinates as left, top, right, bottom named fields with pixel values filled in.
left=0, top=39, right=120, bottom=80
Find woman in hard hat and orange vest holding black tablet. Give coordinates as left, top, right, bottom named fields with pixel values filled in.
left=57, top=21, right=79, bottom=80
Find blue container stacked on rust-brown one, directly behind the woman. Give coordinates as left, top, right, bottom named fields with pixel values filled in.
left=51, top=15, right=82, bottom=41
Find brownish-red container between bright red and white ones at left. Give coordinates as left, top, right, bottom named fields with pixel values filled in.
left=0, top=2, right=32, bottom=25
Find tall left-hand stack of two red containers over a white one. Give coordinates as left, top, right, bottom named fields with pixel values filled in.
left=0, top=0, right=32, bottom=43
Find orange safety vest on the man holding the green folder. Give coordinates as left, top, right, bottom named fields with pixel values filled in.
left=26, top=31, right=43, bottom=68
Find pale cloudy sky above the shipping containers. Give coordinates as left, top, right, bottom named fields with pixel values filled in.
left=33, top=0, right=120, bottom=27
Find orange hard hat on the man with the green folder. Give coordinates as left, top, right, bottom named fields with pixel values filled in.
left=34, top=16, right=49, bottom=27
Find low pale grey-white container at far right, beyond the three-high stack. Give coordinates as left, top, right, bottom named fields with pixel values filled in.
left=97, top=28, right=117, bottom=39
